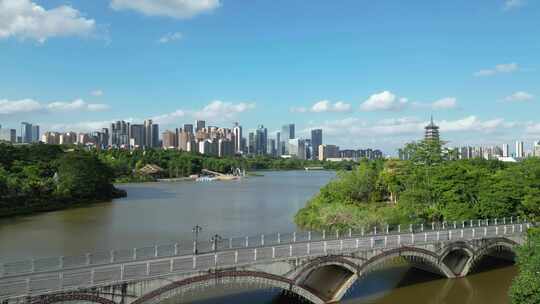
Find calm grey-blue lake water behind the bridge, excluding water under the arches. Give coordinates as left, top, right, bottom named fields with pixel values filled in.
left=0, top=171, right=335, bottom=263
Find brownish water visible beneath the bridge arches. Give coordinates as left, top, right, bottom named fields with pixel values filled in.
left=184, top=258, right=517, bottom=304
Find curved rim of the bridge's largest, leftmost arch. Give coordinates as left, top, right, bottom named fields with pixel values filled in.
left=131, top=271, right=326, bottom=304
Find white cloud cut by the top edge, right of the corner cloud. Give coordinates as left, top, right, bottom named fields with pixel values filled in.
left=111, top=0, right=221, bottom=19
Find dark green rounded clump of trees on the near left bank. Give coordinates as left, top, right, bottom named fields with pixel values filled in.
left=0, top=144, right=125, bottom=217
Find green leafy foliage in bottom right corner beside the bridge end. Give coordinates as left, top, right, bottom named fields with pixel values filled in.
left=510, top=228, right=540, bottom=304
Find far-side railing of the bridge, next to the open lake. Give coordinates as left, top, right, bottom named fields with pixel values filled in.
left=0, top=217, right=523, bottom=278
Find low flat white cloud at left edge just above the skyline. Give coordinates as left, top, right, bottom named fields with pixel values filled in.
left=0, top=99, right=109, bottom=114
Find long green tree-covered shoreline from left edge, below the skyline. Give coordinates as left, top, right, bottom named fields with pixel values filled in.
left=0, top=144, right=354, bottom=217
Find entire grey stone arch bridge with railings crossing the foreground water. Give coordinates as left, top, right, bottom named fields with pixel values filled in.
left=0, top=219, right=532, bottom=304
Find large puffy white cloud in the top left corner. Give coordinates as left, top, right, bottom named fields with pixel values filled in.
left=0, top=0, right=96, bottom=43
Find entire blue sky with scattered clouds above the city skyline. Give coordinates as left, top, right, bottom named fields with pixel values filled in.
left=0, top=0, right=540, bottom=154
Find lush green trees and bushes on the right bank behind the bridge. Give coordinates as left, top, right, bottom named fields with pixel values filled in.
left=295, top=142, right=540, bottom=229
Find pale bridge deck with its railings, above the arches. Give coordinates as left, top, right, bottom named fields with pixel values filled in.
left=0, top=223, right=531, bottom=300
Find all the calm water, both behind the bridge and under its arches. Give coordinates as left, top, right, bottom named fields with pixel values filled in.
left=0, top=171, right=516, bottom=304
